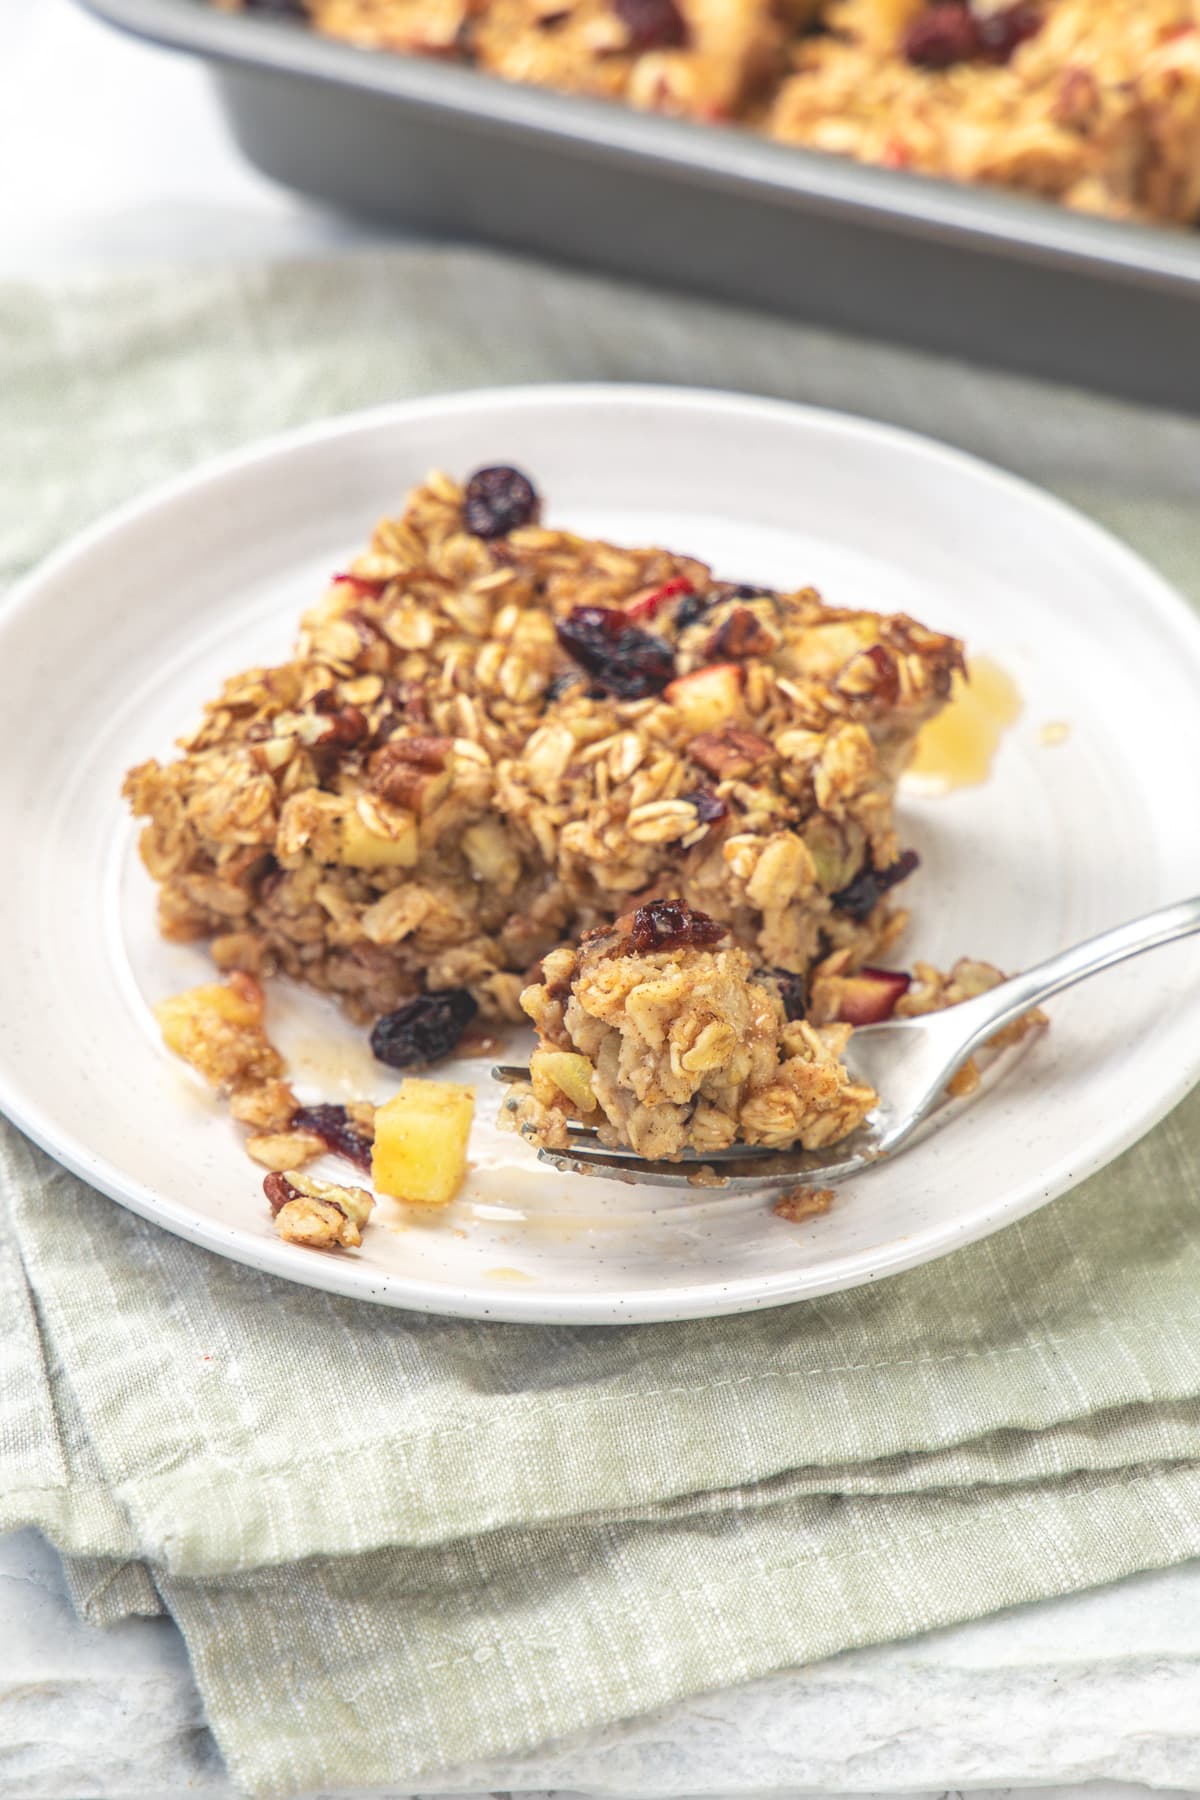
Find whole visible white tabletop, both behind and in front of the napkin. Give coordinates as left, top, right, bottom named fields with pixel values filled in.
left=0, top=0, right=1200, bottom=1800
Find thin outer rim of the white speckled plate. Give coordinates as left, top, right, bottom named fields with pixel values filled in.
left=0, top=383, right=1200, bottom=1325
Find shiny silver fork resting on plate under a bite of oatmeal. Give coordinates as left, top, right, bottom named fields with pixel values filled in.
left=491, top=898, right=1200, bottom=1190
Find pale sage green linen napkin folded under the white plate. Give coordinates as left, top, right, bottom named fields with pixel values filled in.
left=0, top=250, right=1200, bottom=1795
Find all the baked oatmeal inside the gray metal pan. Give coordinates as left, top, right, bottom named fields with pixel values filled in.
left=218, top=0, right=1200, bottom=225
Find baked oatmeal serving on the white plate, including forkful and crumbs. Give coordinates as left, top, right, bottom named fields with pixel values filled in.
left=126, top=466, right=1036, bottom=1244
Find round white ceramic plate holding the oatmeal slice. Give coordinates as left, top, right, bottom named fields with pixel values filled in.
left=0, top=387, right=1200, bottom=1323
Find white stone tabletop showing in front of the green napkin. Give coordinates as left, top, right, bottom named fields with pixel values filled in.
left=0, top=1532, right=1200, bottom=1800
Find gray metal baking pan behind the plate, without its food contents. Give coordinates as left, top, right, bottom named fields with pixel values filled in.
left=85, top=0, right=1200, bottom=410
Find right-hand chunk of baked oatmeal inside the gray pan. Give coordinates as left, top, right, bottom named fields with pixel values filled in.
left=766, top=0, right=1200, bottom=223
